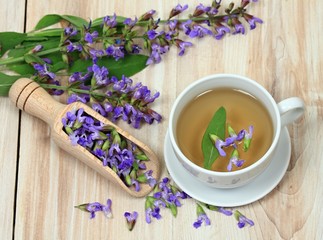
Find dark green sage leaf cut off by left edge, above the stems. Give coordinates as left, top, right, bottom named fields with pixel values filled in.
left=0, top=32, right=27, bottom=57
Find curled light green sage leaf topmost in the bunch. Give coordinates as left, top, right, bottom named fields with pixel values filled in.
left=35, top=14, right=88, bottom=30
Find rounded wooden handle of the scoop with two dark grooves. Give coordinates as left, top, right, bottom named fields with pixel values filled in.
left=9, top=78, right=66, bottom=126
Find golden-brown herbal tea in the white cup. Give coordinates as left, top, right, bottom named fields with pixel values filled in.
left=176, top=88, right=273, bottom=172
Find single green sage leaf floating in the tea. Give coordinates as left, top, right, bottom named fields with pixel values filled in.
left=202, top=107, right=226, bottom=169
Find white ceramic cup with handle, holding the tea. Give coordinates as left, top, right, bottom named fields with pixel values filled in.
left=169, top=74, right=305, bottom=188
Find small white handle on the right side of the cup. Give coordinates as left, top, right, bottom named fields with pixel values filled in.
left=277, top=97, right=305, bottom=127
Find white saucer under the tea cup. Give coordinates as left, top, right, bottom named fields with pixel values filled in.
left=164, top=127, right=291, bottom=207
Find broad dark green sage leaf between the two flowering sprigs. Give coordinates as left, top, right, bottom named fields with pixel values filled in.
left=69, top=54, right=148, bottom=78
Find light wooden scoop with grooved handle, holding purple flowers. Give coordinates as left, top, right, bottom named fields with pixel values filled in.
left=9, top=78, right=160, bottom=197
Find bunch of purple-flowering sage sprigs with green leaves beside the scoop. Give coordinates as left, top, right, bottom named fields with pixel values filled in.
left=0, top=0, right=262, bottom=127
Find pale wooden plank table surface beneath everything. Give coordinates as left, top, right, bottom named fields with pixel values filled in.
left=0, top=0, right=323, bottom=239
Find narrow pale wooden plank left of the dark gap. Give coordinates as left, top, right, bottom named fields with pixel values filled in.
left=0, top=0, right=25, bottom=239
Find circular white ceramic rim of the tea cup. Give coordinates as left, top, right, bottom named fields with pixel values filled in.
left=168, top=74, right=281, bottom=177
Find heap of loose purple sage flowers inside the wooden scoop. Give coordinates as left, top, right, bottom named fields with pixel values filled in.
left=62, top=108, right=156, bottom=191
